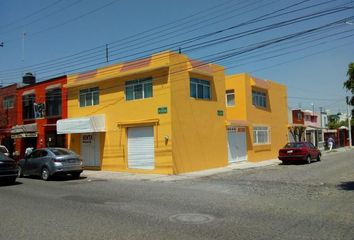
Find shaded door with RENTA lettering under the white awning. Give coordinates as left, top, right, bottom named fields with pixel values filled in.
left=80, top=133, right=100, bottom=167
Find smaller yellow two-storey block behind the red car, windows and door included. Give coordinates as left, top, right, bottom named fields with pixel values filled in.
left=226, top=73, right=288, bottom=163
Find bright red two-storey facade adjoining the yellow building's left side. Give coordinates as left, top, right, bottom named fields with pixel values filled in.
left=11, top=76, right=67, bottom=158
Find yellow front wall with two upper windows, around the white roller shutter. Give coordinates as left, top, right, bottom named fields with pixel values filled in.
left=68, top=51, right=172, bottom=174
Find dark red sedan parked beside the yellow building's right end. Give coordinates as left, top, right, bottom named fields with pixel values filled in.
left=278, top=142, right=321, bottom=164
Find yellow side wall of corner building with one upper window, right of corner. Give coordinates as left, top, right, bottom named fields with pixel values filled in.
left=170, top=54, right=228, bottom=173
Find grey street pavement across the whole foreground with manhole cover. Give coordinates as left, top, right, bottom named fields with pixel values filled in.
left=0, top=151, right=354, bottom=240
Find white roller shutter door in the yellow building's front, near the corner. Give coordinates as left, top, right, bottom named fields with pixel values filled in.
left=128, top=127, right=155, bottom=169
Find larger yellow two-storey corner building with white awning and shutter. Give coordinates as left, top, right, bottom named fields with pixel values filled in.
left=57, top=52, right=228, bottom=174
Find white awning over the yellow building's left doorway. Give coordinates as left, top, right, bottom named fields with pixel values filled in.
left=57, top=115, right=106, bottom=134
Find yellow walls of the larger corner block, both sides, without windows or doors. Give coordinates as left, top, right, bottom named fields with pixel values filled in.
left=67, top=52, right=227, bottom=174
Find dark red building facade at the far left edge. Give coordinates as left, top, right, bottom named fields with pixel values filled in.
left=0, top=84, right=17, bottom=156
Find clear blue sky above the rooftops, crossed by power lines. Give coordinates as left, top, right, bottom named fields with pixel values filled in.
left=0, top=0, right=354, bottom=114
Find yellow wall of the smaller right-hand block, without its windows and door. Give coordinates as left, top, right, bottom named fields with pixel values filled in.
left=226, top=73, right=288, bottom=161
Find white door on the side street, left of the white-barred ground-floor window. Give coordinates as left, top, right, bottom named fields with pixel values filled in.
left=227, top=127, right=247, bottom=163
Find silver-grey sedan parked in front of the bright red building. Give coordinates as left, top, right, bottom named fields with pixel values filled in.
left=18, top=148, right=83, bottom=181
